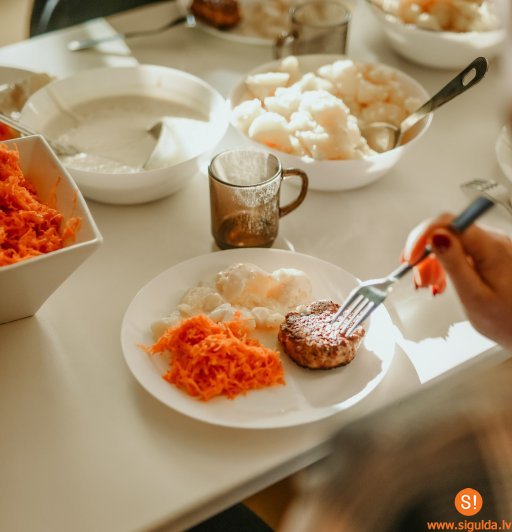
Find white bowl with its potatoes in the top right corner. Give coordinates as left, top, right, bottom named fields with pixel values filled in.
left=367, top=0, right=508, bottom=69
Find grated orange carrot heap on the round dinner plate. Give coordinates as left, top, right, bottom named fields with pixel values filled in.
left=146, top=314, right=285, bottom=401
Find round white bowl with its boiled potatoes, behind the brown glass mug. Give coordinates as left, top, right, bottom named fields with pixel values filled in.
left=230, top=54, right=432, bottom=190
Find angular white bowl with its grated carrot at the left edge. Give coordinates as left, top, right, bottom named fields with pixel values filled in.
left=0, top=136, right=102, bottom=323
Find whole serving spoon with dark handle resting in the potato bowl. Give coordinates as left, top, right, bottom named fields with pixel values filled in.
left=361, top=57, right=488, bottom=153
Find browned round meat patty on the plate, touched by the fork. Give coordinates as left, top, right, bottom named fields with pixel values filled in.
left=278, top=301, right=365, bottom=369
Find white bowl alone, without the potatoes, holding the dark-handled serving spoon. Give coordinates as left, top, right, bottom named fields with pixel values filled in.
left=229, top=54, right=432, bottom=190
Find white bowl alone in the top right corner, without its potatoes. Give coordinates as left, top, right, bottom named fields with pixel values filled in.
left=368, top=0, right=507, bottom=70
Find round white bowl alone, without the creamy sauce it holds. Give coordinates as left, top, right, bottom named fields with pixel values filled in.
left=20, top=65, right=229, bottom=204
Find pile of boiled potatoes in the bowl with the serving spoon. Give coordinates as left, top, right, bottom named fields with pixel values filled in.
left=232, top=56, right=421, bottom=160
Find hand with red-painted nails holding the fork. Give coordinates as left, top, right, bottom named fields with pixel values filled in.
left=402, top=214, right=512, bottom=349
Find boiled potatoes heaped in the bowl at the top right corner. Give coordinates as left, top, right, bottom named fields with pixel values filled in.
left=372, top=0, right=499, bottom=33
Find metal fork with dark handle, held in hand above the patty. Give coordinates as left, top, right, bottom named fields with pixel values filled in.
left=332, top=196, right=495, bottom=336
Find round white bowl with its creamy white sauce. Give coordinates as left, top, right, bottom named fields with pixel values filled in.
left=20, top=65, right=229, bottom=204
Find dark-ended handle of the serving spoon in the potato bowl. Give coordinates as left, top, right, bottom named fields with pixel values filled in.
left=398, top=57, right=489, bottom=144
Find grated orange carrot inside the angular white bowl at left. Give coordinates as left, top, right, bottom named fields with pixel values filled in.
left=0, top=144, right=80, bottom=266
